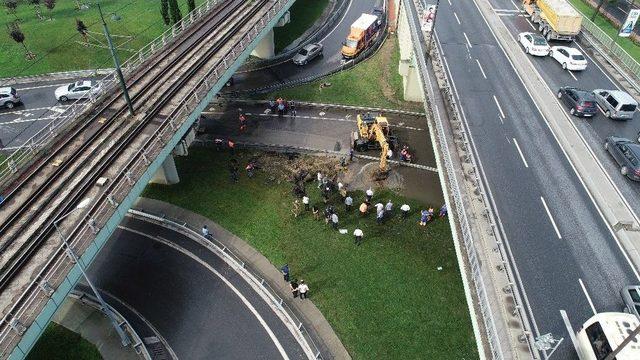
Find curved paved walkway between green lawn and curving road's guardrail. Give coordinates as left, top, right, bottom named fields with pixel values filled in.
left=134, top=198, right=351, bottom=359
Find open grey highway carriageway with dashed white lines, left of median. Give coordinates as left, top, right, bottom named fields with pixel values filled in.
left=436, top=1, right=638, bottom=359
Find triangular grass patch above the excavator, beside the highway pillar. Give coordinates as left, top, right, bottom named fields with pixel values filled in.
left=261, top=36, right=424, bottom=111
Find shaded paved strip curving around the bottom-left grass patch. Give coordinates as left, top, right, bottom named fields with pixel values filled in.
left=53, top=297, right=140, bottom=360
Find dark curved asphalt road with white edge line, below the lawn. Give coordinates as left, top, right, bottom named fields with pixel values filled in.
left=90, top=218, right=306, bottom=359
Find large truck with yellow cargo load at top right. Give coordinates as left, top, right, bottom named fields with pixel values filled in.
left=523, top=0, right=582, bottom=41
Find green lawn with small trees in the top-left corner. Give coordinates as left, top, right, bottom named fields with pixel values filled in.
left=0, top=0, right=204, bottom=77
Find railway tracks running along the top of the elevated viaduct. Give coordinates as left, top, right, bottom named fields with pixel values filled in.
left=0, top=0, right=268, bottom=300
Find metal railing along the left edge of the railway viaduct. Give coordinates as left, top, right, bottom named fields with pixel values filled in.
left=0, top=0, right=225, bottom=191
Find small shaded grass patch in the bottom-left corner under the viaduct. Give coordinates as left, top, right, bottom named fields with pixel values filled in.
left=27, top=322, right=102, bottom=360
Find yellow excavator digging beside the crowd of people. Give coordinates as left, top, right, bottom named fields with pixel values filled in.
left=351, top=113, right=398, bottom=174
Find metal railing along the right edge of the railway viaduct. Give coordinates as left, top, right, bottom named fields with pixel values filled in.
left=0, top=0, right=289, bottom=358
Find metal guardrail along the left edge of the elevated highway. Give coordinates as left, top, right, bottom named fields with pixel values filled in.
left=405, top=0, right=536, bottom=360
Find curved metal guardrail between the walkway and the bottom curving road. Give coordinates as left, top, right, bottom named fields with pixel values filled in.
left=129, top=209, right=322, bottom=360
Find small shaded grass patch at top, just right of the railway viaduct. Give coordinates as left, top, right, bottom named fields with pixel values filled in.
left=273, top=0, right=329, bottom=54
